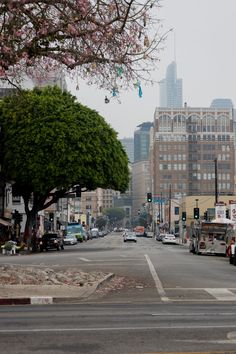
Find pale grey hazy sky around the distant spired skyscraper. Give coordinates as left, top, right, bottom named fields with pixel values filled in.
left=67, top=0, right=236, bottom=138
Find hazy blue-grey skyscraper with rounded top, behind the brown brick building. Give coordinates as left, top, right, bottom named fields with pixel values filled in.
left=159, top=61, right=183, bottom=108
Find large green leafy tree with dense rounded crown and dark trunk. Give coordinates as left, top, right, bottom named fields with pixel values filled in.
left=0, top=87, right=129, bottom=238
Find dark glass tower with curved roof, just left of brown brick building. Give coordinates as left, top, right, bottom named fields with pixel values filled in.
left=134, top=122, right=153, bottom=162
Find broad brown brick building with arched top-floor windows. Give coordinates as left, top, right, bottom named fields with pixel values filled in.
left=153, top=106, right=235, bottom=196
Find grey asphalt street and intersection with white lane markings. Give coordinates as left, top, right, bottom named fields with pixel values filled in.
left=0, top=233, right=236, bottom=354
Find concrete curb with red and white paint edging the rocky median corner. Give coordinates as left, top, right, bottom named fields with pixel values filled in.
left=0, top=273, right=115, bottom=306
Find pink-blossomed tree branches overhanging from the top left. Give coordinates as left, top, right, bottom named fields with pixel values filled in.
left=0, top=0, right=168, bottom=90
